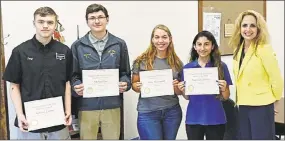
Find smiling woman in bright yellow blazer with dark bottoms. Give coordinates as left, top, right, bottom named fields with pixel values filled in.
left=229, top=10, right=284, bottom=140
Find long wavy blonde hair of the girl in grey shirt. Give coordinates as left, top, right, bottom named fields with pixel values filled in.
left=134, top=24, right=183, bottom=71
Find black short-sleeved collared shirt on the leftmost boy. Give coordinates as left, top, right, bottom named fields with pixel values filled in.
left=3, top=36, right=72, bottom=133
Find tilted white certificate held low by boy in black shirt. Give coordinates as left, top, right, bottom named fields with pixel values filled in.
left=24, top=96, right=65, bottom=131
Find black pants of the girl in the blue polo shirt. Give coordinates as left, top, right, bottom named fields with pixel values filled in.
left=186, top=124, right=225, bottom=140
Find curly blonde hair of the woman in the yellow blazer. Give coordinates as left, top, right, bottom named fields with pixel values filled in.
left=229, top=10, right=269, bottom=59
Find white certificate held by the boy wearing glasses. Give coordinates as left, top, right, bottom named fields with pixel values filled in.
left=82, top=69, right=119, bottom=98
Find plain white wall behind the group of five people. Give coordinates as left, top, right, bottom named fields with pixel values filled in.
left=1, top=1, right=284, bottom=139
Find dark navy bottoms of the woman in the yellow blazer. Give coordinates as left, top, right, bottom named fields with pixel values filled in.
left=238, top=103, right=275, bottom=140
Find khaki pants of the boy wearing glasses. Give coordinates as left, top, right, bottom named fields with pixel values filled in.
left=79, top=108, right=121, bottom=140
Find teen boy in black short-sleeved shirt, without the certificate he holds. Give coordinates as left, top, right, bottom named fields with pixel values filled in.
left=3, top=7, right=72, bottom=139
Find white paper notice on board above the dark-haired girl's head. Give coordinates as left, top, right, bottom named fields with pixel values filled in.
left=203, top=12, right=221, bottom=45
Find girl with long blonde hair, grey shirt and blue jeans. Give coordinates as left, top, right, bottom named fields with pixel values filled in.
left=132, top=24, right=183, bottom=140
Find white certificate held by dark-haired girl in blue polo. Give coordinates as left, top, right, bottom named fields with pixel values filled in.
left=183, top=67, right=220, bottom=95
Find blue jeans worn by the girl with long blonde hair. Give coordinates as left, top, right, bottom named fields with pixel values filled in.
left=137, top=104, right=182, bottom=140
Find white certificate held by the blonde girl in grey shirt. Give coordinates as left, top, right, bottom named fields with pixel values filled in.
left=140, top=69, right=174, bottom=98
